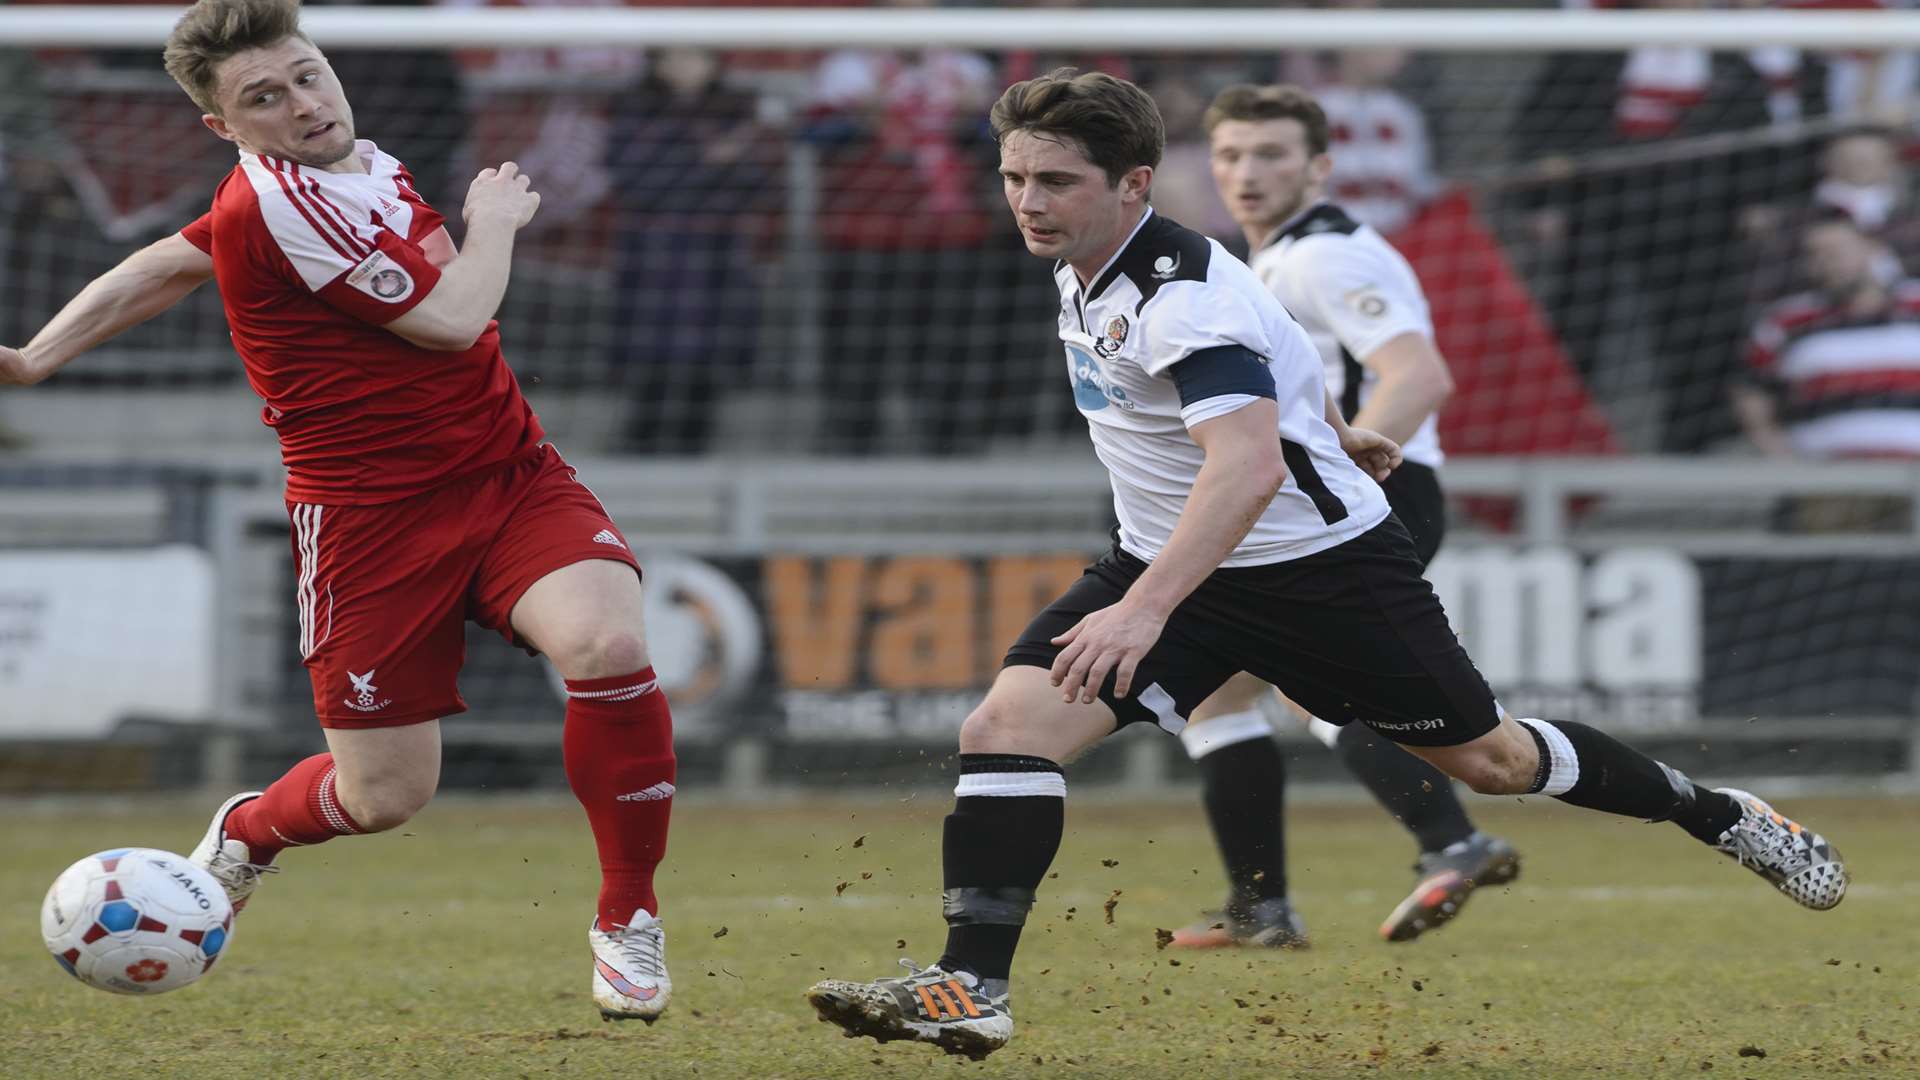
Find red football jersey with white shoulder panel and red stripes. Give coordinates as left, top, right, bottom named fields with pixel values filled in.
left=180, top=140, right=545, bottom=505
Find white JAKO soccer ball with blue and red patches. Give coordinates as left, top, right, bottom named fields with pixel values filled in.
left=40, top=847, right=234, bottom=994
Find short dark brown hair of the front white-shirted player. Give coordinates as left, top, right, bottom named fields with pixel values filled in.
left=991, top=67, right=1167, bottom=186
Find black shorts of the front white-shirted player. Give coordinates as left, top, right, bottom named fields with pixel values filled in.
left=1004, top=515, right=1500, bottom=746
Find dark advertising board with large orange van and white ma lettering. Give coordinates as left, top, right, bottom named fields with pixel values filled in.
left=602, top=544, right=1920, bottom=746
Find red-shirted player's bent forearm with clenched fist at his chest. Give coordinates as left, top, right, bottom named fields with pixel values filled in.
left=386, top=161, right=540, bottom=352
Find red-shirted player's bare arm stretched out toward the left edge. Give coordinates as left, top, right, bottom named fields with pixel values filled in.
left=0, top=233, right=213, bottom=386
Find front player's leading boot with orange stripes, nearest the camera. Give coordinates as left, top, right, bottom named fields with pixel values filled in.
left=806, top=959, right=1014, bottom=1061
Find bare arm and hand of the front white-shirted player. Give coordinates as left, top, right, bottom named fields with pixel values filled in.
left=1052, top=398, right=1286, bottom=701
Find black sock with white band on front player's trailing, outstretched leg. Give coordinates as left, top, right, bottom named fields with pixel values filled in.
left=1523, top=721, right=1740, bottom=844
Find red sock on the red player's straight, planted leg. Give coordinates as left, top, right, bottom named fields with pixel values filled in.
left=561, top=667, right=674, bottom=930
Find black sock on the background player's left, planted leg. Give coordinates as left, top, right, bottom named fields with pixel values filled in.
left=1194, top=734, right=1286, bottom=903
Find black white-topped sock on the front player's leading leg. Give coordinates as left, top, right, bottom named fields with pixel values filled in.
left=939, top=753, right=1068, bottom=990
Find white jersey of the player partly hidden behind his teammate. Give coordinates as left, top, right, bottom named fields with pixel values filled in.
left=1250, top=202, right=1444, bottom=469
